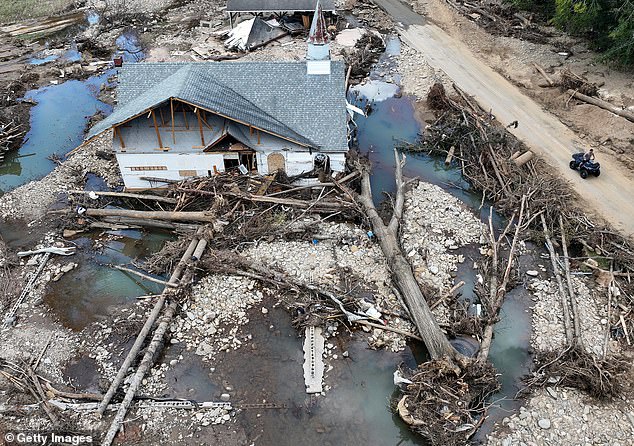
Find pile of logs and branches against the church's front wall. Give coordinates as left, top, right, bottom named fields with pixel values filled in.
left=62, top=173, right=360, bottom=247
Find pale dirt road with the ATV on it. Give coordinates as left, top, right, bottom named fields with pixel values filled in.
left=374, top=0, right=634, bottom=237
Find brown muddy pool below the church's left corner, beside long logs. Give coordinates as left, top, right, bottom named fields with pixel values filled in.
left=44, top=230, right=171, bottom=330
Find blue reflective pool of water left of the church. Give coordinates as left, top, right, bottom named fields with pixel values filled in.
left=0, top=73, right=112, bottom=194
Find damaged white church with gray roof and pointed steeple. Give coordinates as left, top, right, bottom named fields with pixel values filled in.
left=87, top=2, right=348, bottom=189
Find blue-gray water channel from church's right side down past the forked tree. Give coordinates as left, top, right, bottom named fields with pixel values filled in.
left=349, top=82, right=535, bottom=438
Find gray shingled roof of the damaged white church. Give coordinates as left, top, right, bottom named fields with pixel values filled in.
left=88, top=61, right=348, bottom=151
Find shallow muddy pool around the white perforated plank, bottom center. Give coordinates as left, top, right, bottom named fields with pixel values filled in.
left=188, top=308, right=424, bottom=446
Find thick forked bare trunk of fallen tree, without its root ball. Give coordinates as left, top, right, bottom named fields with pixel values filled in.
left=350, top=149, right=463, bottom=362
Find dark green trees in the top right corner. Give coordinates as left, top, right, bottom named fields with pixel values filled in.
left=507, top=0, right=634, bottom=67
